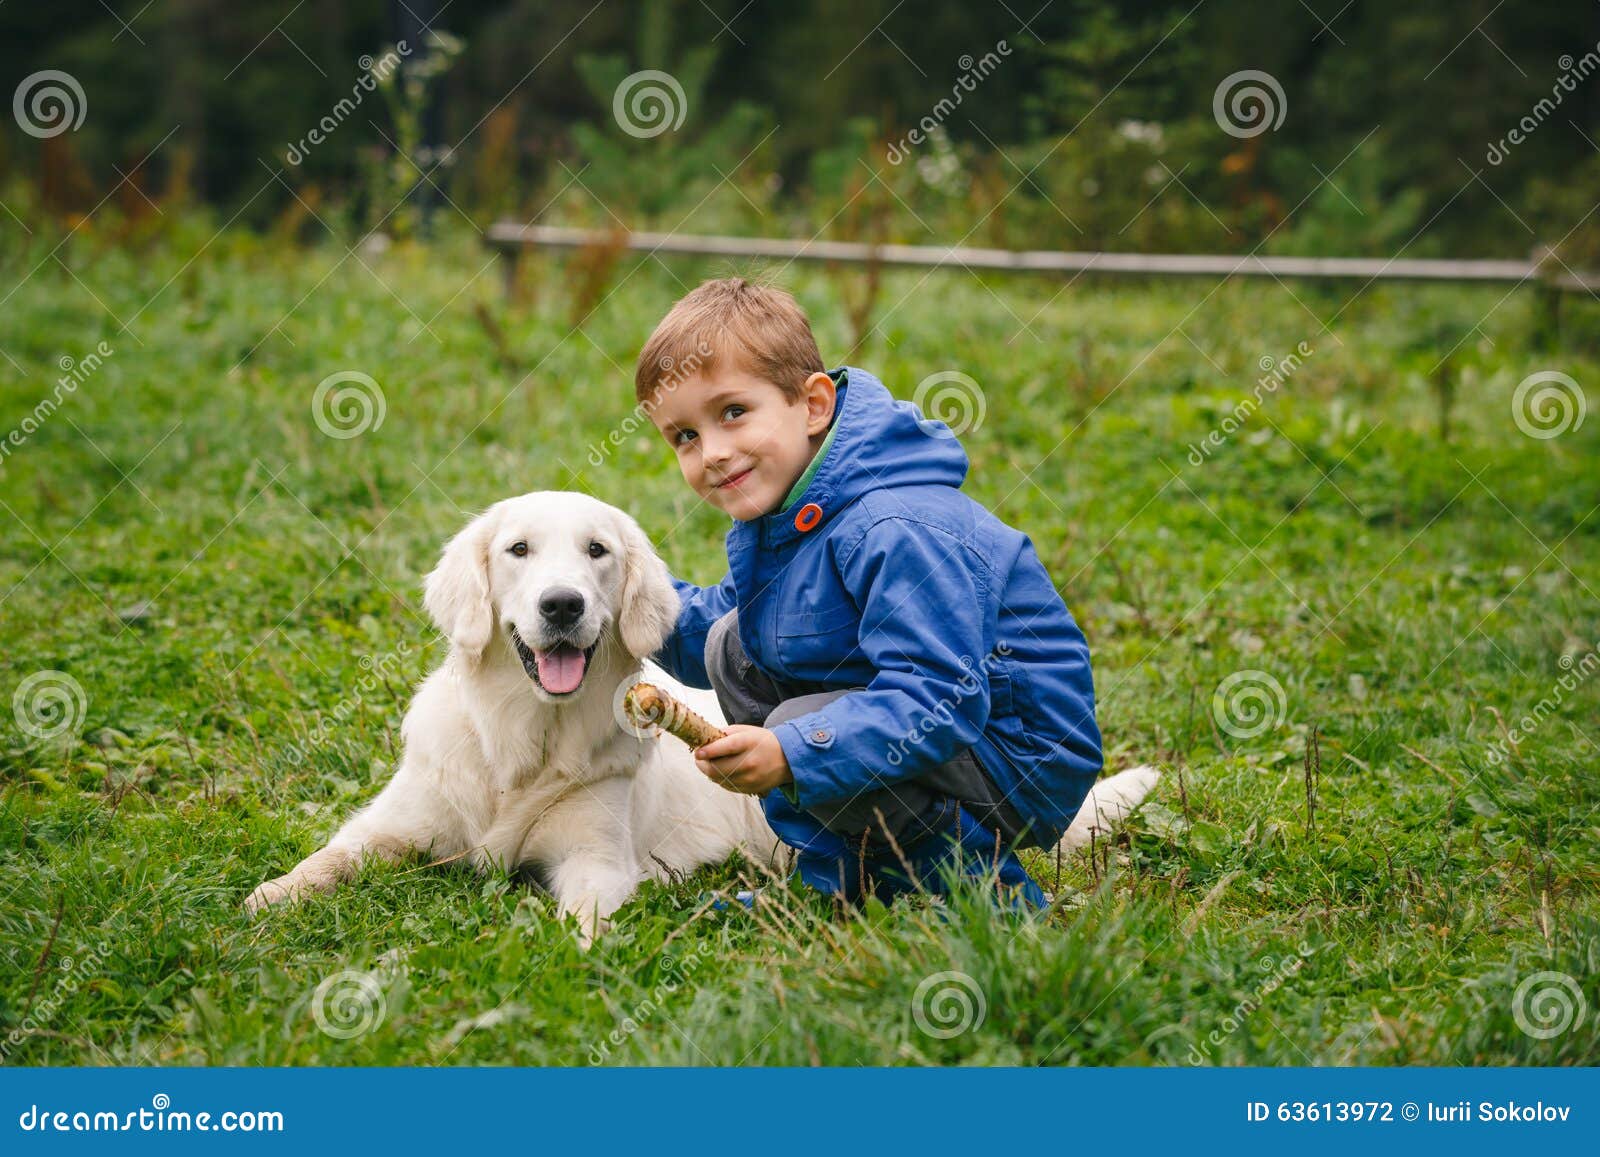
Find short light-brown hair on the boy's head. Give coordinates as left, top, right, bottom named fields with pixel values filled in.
left=634, top=277, right=826, bottom=402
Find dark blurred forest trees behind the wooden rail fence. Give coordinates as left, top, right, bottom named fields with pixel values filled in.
left=0, top=0, right=1600, bottom=256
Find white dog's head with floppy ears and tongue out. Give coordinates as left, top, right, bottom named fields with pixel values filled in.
left=422, top=490, right=678, bottom=701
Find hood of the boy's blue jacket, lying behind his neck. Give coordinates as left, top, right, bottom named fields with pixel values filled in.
left=757, top=365, right=968, bottom=542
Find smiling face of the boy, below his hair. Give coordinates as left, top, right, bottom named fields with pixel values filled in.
left=650, top=363, right=834, bottom=522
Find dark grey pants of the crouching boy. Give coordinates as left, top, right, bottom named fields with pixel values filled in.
left=706, top=611, right=1024, bottom=848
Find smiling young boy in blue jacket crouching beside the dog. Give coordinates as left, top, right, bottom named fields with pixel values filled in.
left=635, top=278, right=1101, bottom=904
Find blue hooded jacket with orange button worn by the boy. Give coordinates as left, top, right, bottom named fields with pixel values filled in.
left=656, top=366, right=1101, bottom=847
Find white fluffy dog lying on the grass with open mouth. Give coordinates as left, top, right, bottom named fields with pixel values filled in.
left=245, top=491, right=1157, bottom=944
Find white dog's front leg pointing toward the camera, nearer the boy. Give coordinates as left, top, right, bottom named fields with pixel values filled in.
left=522, top=776, right=640, bottom=949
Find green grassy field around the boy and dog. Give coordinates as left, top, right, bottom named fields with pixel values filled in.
left=0, top=221, right=1600, bottom=1064
